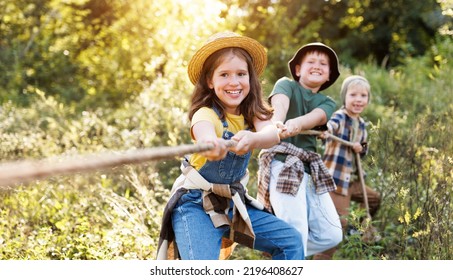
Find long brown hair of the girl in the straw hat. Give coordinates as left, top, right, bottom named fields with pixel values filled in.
left=189, top=48, right=273, bottom=129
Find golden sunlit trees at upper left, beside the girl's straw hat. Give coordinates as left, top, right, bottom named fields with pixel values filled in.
left=0, top=0, right=230, bottom=108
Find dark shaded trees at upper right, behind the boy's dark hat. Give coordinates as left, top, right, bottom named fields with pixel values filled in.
left=220, top=0, right=453, bottom=74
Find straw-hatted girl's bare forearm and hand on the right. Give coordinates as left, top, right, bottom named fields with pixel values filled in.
left=230, top=118, right=280, bottom=155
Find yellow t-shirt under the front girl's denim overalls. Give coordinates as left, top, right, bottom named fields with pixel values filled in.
left=189, top=107, right=245, bottom=170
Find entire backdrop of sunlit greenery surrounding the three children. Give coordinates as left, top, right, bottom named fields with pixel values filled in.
left=0, top=0, right=453, bottom=260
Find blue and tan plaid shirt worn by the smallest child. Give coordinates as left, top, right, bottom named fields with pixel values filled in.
left=323, top=108, right=368, bottom=195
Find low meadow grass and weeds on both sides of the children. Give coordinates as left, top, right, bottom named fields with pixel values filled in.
left=0, top=34, right=453, bottom=260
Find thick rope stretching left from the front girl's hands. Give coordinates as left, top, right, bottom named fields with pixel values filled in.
left=0, top=140, right=236, bottom=186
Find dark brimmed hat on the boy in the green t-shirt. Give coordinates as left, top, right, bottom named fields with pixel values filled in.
left=288, top=42, right=340, bottom=91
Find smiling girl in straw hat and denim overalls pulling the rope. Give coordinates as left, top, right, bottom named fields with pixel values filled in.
left=158, top=32, right=304, bottom=260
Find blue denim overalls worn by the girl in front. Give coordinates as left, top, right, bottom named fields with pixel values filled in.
left=172, top=108, right=304, bottom=260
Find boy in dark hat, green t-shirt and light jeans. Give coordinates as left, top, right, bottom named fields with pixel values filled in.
left=258, top=43, right=343, bottom=256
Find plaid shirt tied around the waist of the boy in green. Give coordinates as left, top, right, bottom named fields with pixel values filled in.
left=257, top=142, right=336, bottom=212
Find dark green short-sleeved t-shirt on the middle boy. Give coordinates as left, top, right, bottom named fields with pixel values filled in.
left=269, top=77, right=336, bottom=171
